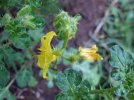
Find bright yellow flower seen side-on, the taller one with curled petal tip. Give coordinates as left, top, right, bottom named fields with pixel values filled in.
left=37, top=31, right=56, bottom=78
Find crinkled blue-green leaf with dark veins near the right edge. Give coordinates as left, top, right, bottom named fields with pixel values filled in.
left=110, top=45, right=133, bottom=70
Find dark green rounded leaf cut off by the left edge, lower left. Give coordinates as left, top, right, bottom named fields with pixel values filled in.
left=0, top=64, right=10, bottom=88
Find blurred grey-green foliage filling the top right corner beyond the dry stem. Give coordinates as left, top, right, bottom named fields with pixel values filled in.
left=103, top=0, right=134, bottom=49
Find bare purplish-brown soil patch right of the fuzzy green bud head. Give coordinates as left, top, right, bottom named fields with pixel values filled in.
left=61, top=0, right=108, bottom=47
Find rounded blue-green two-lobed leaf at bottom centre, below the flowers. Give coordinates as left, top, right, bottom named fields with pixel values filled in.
left=56, top=69, right=82, bottom=92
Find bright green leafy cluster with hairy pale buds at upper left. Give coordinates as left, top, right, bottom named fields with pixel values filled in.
left=2, top=5, right=40, bottom=49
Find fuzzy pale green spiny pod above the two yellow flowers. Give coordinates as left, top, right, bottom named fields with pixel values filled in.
left=54, top=11, right=81, bottom=40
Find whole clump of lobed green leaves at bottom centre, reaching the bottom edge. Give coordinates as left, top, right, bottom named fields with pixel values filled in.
left=55, top=69, right=91, bottom=100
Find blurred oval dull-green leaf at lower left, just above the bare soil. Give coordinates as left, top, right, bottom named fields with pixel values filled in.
left=16, top=66, right=33, bottom=88
